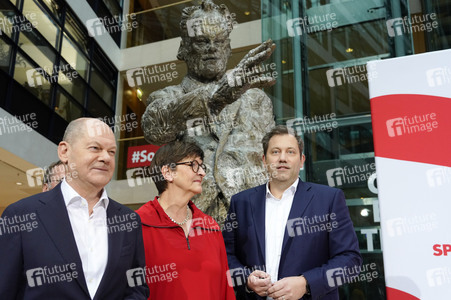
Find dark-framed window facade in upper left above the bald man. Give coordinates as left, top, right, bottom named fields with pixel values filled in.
left=0, top=0, right=118, bottom=143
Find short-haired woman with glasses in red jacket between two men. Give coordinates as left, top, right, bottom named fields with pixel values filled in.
left=137, top=141, right=235, bottom=300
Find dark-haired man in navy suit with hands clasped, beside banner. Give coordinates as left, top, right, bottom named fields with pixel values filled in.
left=223, top=126, right=362, bottom=300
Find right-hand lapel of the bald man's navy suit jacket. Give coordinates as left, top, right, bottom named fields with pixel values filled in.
left=94, top=199, right=124, bottom=299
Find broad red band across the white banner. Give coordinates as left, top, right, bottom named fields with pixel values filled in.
left=371, top=94, right=451, bottom=167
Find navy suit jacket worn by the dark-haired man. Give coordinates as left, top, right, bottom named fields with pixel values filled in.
left=223, top=180, right=362, bottom=299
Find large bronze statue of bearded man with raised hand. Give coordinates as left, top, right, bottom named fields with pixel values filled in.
left=142, top=0, right=277, bottom=223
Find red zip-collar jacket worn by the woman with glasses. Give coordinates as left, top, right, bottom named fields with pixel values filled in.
left=137, top=197, right=235, bottom=300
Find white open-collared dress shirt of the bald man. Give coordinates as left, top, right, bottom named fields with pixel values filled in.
left=61, top=179, right=109, bottom=298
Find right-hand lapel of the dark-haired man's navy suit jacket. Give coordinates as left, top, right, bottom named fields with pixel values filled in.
left=280, top=179, right=313, bottom=258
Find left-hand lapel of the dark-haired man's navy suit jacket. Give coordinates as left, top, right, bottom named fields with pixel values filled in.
left=250, top=185, right=266, bottom=264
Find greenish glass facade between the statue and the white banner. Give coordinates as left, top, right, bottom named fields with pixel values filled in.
left=262, top=0, right=451, bottom=299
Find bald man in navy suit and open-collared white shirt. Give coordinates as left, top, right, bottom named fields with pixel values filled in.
left=0, top=118, right=149, bottom=300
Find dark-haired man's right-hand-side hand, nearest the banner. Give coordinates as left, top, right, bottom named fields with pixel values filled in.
left=268, top=276, right=307, bottom=300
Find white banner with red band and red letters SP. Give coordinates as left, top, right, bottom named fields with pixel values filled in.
left=368, top=50, right=451, bottom=300
